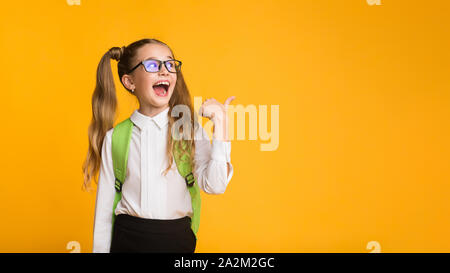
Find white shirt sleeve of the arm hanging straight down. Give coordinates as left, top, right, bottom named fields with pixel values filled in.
left=92, top=129, right=115, bottom=252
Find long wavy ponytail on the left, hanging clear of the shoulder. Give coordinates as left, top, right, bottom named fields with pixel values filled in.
left=82, top=47, right=125, bottom=191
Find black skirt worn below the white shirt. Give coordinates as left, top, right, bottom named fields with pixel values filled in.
left=110, top=214, right=197, bottom=253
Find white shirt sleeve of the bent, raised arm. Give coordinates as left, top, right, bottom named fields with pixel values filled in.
left=194, top=125, right=233, bottom=194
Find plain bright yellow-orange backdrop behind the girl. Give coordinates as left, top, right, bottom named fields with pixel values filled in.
left=0, top=0, right=450, bottom=252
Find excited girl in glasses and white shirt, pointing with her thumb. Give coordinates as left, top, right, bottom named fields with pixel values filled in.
left=83, top=39, right=234, bottom=252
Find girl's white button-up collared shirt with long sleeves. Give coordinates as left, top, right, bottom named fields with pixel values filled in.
left=93, top=108, right=233, bottom=252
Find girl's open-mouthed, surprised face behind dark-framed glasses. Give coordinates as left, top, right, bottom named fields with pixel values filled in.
left=122, top=44, right=177, bottom=115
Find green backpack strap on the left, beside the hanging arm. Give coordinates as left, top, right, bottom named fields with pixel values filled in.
left=111, top=118, right=133, bottom=227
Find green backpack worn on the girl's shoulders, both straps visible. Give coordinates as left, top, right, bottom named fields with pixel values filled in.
left=111, top=118, right=201, bottom=238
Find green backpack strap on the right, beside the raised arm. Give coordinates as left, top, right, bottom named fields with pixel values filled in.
left=173, top=141, right=201, bottom=237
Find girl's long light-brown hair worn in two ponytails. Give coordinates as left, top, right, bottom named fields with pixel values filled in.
left=82, top=39, right=198, bottom=191
